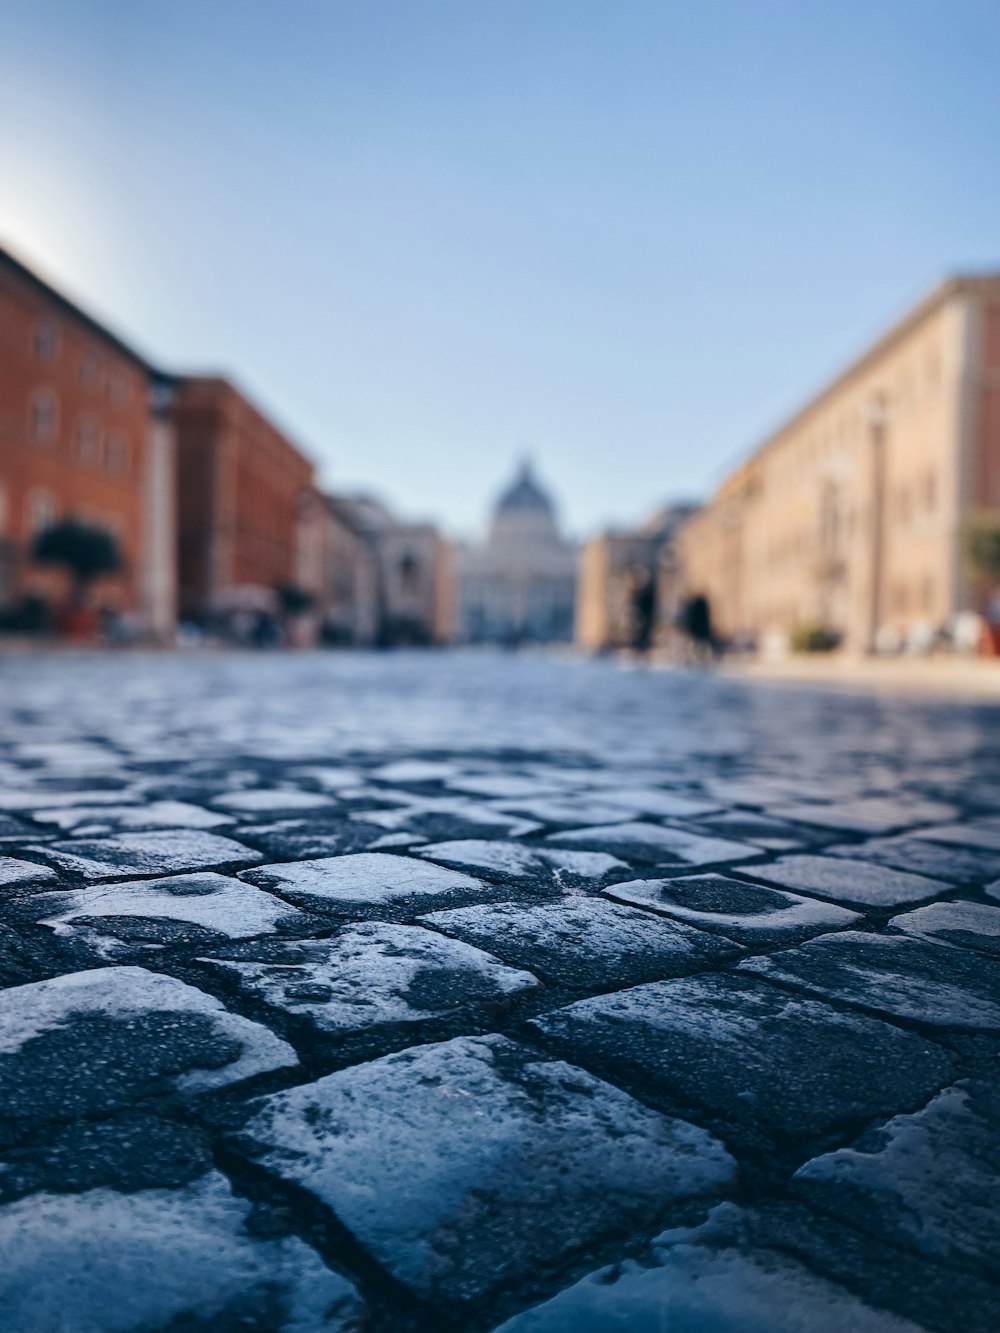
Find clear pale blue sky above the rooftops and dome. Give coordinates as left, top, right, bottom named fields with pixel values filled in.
left=0, top=0, right=1000, bottom=535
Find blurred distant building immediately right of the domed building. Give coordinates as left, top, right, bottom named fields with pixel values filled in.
left=576, top=504, right=697, bottom=652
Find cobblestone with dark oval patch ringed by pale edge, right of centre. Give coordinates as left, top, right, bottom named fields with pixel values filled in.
left=603, top=874, right=861, bottom=945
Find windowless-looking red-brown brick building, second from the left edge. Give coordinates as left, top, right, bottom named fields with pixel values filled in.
left=172, top=376, right=313, bottom=621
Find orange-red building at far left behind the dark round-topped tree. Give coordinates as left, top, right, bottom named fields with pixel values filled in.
left=0, top=249, right=175, bottom=635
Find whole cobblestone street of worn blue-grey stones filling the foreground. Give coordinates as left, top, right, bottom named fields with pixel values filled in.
left=0, top=653, right=1000, bottom=1333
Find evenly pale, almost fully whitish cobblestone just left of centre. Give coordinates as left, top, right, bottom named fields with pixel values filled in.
left=240, top=852, right=499, bottom=910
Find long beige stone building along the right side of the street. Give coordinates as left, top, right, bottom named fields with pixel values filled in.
left=680, top=275, right=1000, bottom=651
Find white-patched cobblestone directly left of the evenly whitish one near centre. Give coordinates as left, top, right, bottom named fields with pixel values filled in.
left=35, top=872, right=303, bottom=940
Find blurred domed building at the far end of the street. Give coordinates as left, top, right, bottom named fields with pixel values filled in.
left=455, top=463, right=576, bottom=645
